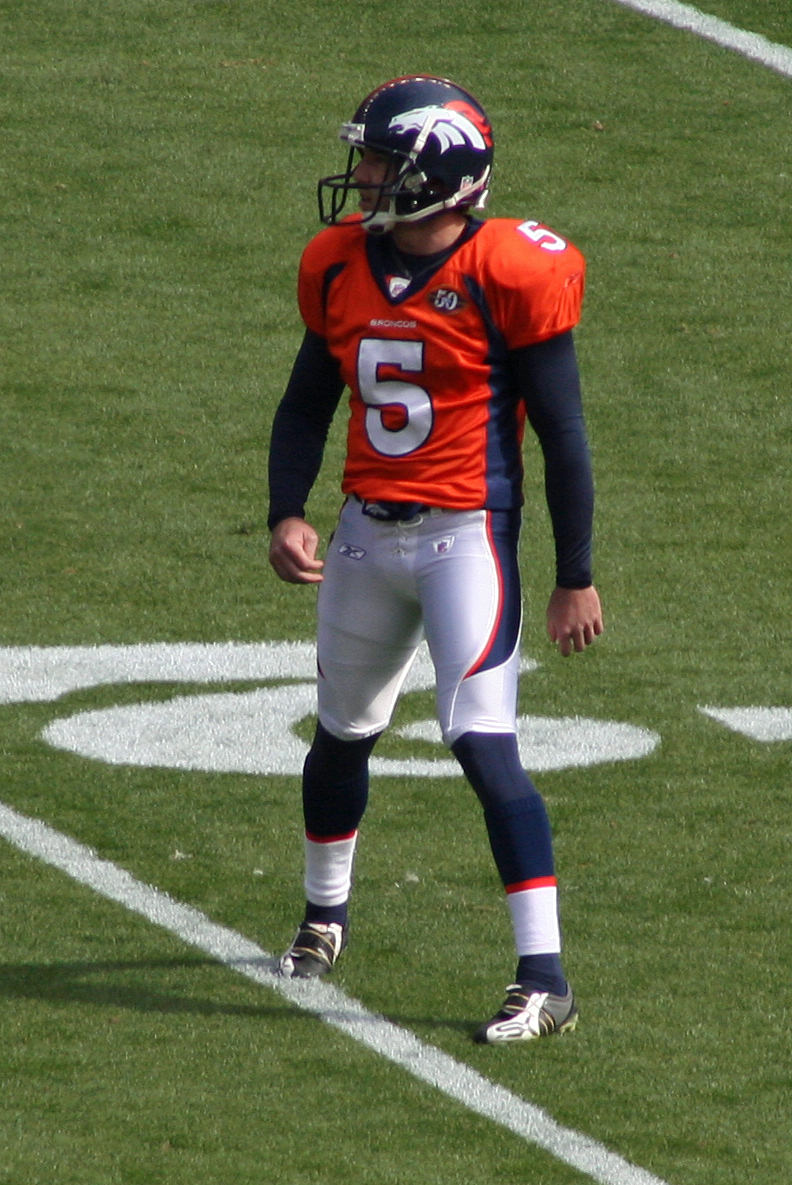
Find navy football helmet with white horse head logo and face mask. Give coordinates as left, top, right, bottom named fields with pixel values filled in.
left=319, top=75, right=493, bottom=232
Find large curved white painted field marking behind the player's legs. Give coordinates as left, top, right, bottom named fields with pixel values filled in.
left=0, top=642, right=659, bottom=777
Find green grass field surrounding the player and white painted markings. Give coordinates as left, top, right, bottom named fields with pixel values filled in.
left=0, top=0, right=792, bottom=1185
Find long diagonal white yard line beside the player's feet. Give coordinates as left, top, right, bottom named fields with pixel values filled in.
left=0, top=803, right=665, bottom=1185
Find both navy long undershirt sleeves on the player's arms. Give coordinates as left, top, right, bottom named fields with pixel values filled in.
left=268, top=329, right=594, bottom=588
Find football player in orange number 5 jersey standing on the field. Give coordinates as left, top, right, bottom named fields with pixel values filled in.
left=269, top=75, right=602, bottom=1043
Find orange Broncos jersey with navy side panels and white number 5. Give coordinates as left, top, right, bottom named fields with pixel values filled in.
left=299, top=218, right=585, bottom=510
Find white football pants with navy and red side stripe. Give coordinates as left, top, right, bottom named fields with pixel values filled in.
left=318, top=499, right=520, bottom=745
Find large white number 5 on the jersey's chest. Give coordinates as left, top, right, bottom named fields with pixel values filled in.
left=358, top=338, right=434, bottom=456
